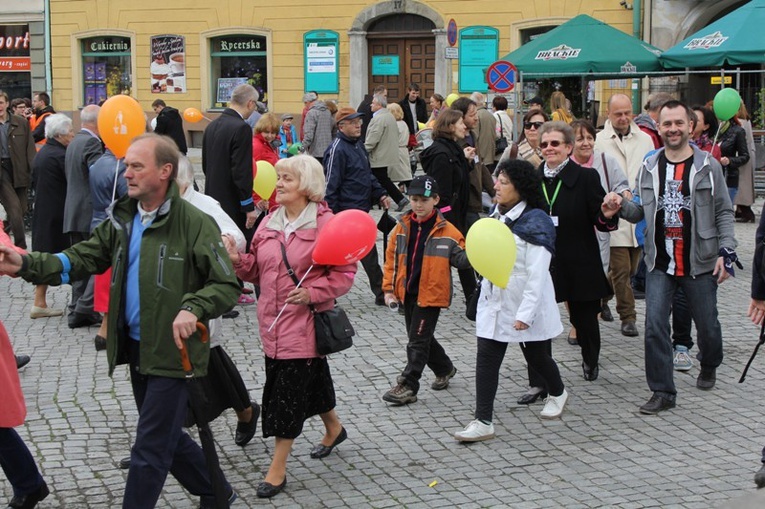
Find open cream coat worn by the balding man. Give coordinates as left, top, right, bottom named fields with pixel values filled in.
left=595, top=120, right=654, bottom=247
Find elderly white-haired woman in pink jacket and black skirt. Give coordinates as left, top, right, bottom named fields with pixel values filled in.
left=226, top=155, right=356, bottom=498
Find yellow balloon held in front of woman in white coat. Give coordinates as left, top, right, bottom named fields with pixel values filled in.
left=465, top=217, right=515, bottom=288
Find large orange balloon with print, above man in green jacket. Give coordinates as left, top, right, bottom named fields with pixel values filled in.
left=98, top=95, right=146, bottom=159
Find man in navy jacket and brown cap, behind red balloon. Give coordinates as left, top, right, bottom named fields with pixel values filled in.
left=323, top=107, right=393, bottom=306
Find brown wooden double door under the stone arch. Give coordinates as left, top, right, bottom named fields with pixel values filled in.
left=368, top=35, right=436, bottom=102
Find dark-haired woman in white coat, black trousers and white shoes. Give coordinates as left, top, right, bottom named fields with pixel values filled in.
left=454, top=159, right=568, bottom=442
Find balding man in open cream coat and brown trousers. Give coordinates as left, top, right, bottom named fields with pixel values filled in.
left=595, top=94, right=654, bottom=337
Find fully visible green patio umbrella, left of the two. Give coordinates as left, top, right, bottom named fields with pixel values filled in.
left=502, top=14, right=661, bottom=78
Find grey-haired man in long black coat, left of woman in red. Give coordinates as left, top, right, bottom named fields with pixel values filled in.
left=202, top=84, right=259, bottom=246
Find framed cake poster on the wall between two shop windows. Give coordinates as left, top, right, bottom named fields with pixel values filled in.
left=150, top=35, right=186, bottom=94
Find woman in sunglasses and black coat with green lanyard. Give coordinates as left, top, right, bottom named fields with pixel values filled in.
left=539, top=122, right=619, bottom=382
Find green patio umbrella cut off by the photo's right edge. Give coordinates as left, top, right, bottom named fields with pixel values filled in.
left=661, top=0, right=765, bottom=69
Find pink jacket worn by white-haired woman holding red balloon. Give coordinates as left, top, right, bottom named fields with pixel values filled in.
left=234, top=202, right=356, bottom=359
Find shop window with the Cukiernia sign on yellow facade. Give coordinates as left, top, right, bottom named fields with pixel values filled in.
left=82, top=36, right=133, bottom=105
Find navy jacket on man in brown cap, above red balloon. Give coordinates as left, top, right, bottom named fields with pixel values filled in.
left=323, top=131, right=388, bottom=214
